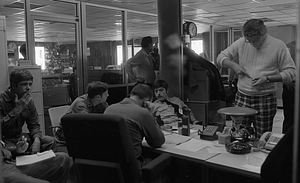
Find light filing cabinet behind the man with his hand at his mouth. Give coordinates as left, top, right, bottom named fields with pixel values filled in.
left=8, top=65, right=45, bottom=135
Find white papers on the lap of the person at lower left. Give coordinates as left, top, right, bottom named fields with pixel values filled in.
left=16, top=150, right=55, bottom=166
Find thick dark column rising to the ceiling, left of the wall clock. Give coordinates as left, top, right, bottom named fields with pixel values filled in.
left=157, top=0, right=183, bottom=98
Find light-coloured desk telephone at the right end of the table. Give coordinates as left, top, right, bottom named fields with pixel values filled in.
left=259, top=132, right=284, bottom=151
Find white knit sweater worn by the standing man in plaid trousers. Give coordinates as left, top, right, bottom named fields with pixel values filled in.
left=217, top=35, right=296, bottom=96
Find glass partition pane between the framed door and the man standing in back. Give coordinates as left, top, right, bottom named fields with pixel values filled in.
left=85, top=6, right=123, bottom=85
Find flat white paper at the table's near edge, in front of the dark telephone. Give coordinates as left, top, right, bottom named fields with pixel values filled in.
left=174, top=139, right=212, bottom=152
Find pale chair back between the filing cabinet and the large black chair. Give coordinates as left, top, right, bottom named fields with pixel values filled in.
left=48, top=105, right=70, bottom=145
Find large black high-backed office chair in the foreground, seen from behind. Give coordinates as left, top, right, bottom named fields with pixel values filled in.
left=61, top=114, right=171, bottom=183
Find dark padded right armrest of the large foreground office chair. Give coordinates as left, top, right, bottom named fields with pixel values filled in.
left=142, top=153, right=172, bottom=180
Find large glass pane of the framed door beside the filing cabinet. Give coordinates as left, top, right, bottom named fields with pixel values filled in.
left=34, top=20, right=77, bottom=107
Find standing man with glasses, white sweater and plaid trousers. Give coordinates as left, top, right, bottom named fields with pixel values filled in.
left=217, top=19, right=296, bottom=138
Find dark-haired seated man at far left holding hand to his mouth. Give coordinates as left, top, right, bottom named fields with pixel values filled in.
left=0, top=70, right=56, bottom=154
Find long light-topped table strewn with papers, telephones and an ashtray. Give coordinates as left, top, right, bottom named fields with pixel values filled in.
left=143, top=124, right=266, bottom=183
